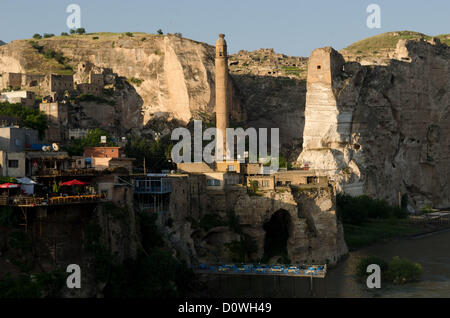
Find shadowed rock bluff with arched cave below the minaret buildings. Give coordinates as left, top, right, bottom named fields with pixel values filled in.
left=158, top=176, right=348, bottom=264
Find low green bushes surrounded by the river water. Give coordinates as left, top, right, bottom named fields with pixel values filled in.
left=356, top=256, right=423, bottom=284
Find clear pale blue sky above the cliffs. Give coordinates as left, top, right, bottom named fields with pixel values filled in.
left=0, top=0, right=450, bottom=56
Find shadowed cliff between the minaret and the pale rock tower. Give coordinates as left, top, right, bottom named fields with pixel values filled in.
left=229, top=49, right=307, bottom=161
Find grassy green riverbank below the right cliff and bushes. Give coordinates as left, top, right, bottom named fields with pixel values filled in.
left=344, top=219, right=450, bottom=251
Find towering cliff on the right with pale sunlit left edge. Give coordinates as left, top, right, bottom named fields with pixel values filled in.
left=299, top=39, right=450, bottom=208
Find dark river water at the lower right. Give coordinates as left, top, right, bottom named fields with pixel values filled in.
left=204, top=231, right=450, bottom=298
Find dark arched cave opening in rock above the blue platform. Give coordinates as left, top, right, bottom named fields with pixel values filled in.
left=263, top=209, right=291, bottom=261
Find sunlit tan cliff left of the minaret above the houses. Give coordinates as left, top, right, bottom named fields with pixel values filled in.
left=0, top=33, right=245, bottom=128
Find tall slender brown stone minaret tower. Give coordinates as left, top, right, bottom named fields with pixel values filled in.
left=216, top=34, right=228, bottom=160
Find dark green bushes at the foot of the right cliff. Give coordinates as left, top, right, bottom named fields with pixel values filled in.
left=336, top=193, right=407, bottom=225
